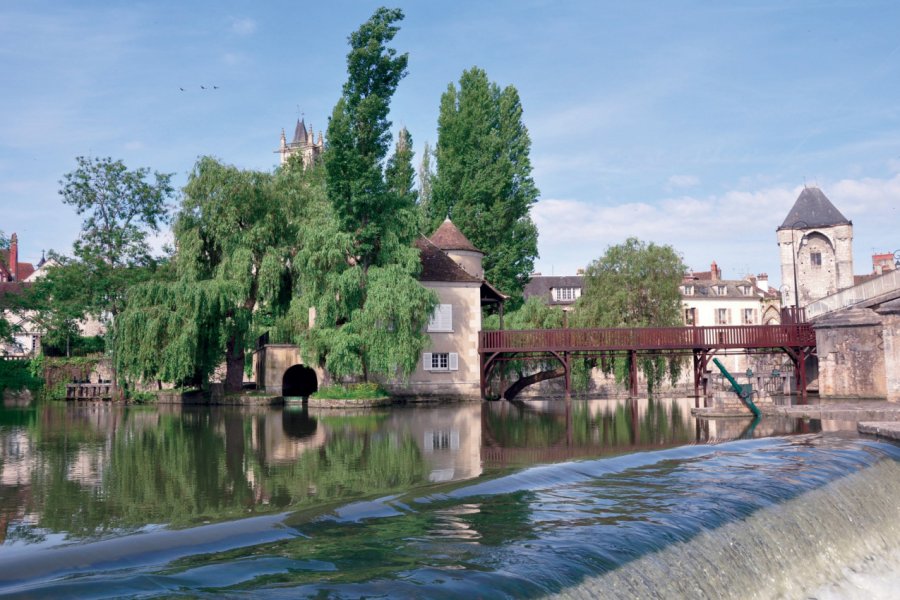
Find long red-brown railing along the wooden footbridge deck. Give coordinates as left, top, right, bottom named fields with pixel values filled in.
left=478, top=323, right=816, bottom=353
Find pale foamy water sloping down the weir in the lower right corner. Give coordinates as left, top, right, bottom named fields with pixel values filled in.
left=558, top=460, right=900, bottom=600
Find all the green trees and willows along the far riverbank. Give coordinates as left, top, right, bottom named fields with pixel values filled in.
left=0, top=8, right=683, bottom=395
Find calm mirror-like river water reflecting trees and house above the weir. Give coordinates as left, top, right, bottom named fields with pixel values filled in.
left=0, top=399, right=808, bottom=548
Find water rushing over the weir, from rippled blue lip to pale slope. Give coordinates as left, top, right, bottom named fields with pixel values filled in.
left=0, top=428, right=900, bottom=598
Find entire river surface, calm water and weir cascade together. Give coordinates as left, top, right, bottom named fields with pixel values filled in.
left=0, top=399, right=900, bottom=599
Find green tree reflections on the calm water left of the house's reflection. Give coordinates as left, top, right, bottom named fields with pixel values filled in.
left=0, top=404, right=429, bottom=542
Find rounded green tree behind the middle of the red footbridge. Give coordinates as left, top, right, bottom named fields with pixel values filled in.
left=574, top=238, right=685, bottom=392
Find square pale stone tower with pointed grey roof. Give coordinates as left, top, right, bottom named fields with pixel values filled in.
left=776, top=187, right=853, bottom=307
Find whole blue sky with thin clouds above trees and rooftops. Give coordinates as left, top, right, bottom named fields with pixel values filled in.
left=0, top=0, right=900, bottom=287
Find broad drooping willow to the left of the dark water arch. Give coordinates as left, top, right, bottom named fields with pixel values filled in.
left=117, top=158, right=315, bottom=391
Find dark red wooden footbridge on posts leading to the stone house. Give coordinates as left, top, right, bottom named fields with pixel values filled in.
left=478, top=321, right=816, bottom=398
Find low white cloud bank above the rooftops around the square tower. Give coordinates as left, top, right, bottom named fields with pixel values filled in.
left=532, top=174, right=900, bottom=284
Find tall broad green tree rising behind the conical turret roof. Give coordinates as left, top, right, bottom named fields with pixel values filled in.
left=427, top=67, right=539, bottom=305
